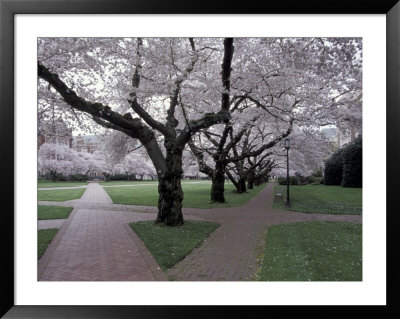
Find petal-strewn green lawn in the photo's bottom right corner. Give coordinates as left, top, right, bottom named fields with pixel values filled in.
left=259, top=222, right=362, bottom=281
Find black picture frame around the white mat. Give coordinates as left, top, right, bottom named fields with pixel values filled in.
left=0, top=0, right=400, bottom=318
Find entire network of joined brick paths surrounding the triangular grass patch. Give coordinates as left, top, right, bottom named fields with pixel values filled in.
left=38, top=182, right=362, bottom=281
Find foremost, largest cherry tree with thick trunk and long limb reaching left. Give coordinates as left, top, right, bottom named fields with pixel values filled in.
left=38, top=38, right=233, bottom=225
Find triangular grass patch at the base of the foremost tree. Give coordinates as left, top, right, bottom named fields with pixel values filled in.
left=129, top=220, right=219, bottom=271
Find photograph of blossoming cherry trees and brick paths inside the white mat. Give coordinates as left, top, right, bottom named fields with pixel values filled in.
left=37, top=37, right=363, bottom=281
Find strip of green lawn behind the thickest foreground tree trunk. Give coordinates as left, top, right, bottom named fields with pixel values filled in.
left=104, top=181, right=265, bottom=208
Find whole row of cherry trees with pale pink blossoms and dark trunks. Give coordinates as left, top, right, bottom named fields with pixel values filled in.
left=38, top=38, right=362, bottom=225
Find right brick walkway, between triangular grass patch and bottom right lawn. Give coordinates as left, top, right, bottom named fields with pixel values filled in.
left=168, top=182, right=361, bottom=281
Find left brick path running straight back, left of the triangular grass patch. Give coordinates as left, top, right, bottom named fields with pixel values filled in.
left=38, top=183, right=166, bottom=281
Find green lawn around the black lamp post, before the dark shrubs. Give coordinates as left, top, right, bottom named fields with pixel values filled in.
left=274, top=185, right=362, bottom=215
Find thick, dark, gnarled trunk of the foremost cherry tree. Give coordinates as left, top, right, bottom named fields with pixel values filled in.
left=156, top=151, right=184, bottom=226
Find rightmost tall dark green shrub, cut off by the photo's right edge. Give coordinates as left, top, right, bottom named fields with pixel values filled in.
left=341, top=136, right=362, bottom=187
